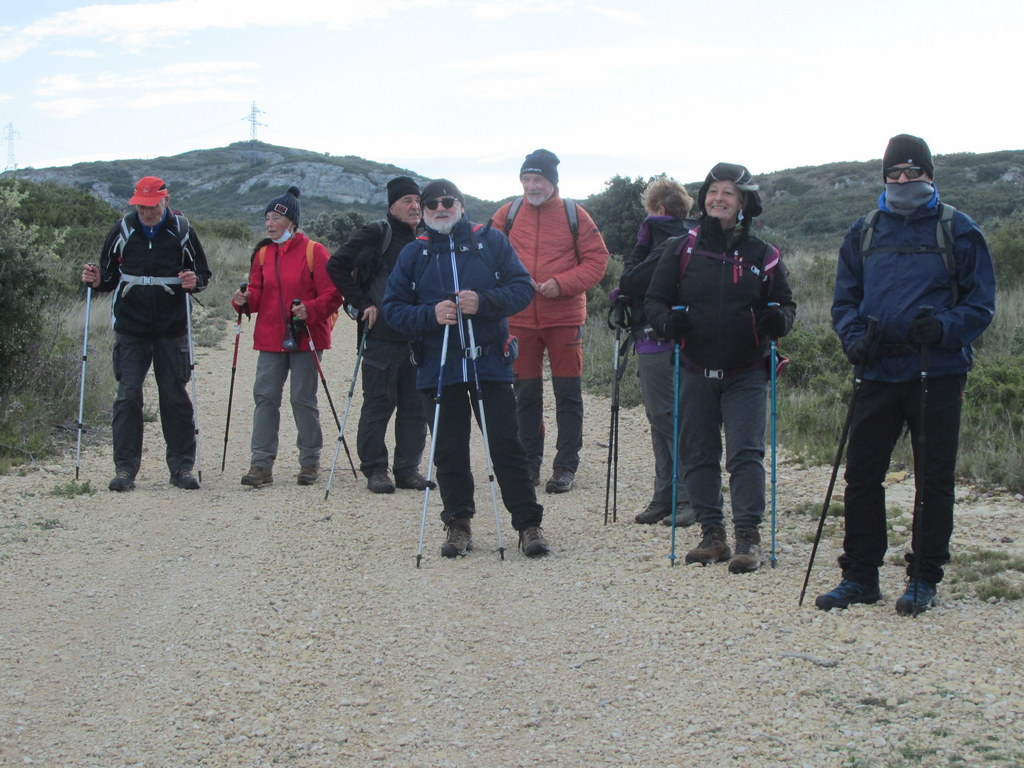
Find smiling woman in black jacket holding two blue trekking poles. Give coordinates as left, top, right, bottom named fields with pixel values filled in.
left=644, top=163, right=796, bottom=573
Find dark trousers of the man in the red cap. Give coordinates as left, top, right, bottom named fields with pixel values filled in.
left=111, top=334, right=196, bottom=477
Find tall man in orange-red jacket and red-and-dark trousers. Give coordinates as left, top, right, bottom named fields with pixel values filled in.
left=494, top=150, right=608, bottom=494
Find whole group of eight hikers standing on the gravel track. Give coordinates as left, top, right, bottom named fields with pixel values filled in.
left=79, top=134, right=994, bottom=614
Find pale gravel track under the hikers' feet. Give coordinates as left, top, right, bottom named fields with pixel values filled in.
left=0, top=315, right=1024, bottom=768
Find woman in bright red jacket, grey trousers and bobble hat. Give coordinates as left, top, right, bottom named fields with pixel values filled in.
left=231, top=186, right=342, bottom=487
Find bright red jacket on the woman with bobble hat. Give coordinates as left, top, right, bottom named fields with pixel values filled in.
left=236, top=232, right=343, bottom=352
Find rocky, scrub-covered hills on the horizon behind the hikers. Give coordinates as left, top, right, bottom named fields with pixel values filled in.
left=0, top=141, right=1024, bottom=249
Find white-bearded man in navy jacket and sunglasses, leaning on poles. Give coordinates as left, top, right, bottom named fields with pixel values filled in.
left=381, top=179, right=549, bottom=557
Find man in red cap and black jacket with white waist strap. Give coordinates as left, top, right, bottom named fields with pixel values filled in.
left=82, top=176, right=210, bottom=492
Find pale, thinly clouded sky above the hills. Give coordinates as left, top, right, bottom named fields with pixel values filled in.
left=0, top=0, right=1024, bottom=200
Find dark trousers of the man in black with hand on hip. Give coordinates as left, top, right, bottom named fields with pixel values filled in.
left=355, top=337, right=427, bottom=477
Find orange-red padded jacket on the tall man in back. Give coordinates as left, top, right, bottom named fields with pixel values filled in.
left=493, top=190, right=608, bottom=329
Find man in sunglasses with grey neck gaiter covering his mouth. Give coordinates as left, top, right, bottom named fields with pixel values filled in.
left=815, top=133, right=995, bottom=615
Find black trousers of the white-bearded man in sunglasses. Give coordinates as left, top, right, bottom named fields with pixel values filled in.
left=428, top=381, right=544, bottom=530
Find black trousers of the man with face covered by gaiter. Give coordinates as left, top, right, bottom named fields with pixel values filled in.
left=839, top=376, right=967, bottom=584
